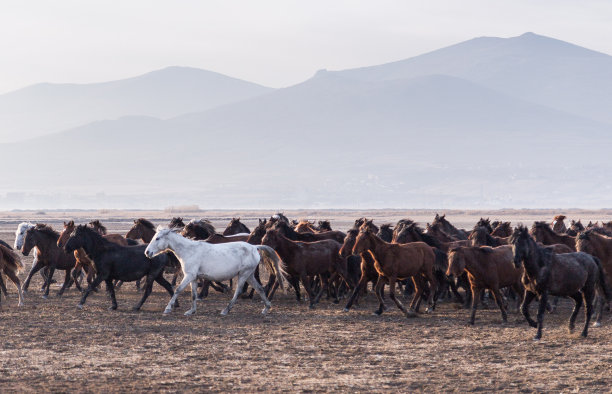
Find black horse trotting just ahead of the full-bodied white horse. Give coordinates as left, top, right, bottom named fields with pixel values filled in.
left=64, top=225, right=173, bottom=310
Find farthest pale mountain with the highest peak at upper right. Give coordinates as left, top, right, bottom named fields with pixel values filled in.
left=336, top=33, right=612, bottom=124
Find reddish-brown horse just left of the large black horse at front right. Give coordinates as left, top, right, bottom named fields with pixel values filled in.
left=446, top=245, right=523, bottom=325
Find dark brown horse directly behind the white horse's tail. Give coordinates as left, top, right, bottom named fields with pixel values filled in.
left=261, top=228, right=354, bottom=309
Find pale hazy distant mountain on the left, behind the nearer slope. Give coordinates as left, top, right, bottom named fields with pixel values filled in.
left=0, top=67, right=272, bottom=141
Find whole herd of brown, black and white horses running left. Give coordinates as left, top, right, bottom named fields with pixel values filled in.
left=0, top=213, right=612, bottom=339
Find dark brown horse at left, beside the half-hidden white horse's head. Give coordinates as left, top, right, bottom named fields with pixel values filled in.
left=21, top=224, right=82, bottom=299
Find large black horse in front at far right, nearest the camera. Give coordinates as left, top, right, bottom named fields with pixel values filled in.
left=510, top=226, right=610, bottom=340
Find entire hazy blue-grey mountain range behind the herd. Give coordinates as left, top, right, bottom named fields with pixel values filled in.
left=0, top=33, right=612, bottom=208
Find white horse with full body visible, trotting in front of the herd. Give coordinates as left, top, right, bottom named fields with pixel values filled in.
left=145, top=227, right=285, bottom=315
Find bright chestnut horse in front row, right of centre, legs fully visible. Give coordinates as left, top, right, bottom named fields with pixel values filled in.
left=353, top=225, right=438, bottom=317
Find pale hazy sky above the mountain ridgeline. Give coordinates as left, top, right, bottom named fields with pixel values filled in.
left=0, top=0, right=612, bottom=93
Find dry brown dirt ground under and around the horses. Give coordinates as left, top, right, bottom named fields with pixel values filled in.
left=0, top=212, right=612, bottom=392
